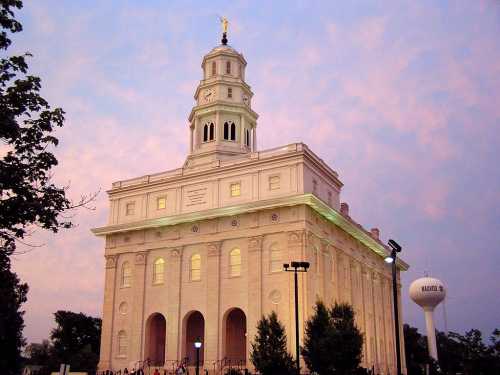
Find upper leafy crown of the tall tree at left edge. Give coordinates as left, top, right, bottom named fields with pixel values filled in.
left=0, top=0, right=71, bottom=255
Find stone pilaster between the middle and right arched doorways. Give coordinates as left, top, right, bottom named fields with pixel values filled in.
left=204, top=241, right=222, bottom=368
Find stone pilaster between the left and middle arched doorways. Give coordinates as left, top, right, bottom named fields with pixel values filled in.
left=165, top=247, right=182, bottom=365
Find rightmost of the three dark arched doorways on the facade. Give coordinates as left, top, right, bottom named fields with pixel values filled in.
left=224, top=308, right=247, bottom=364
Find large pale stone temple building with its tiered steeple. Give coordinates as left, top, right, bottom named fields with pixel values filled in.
left=93, top=29, right=408, bottom=374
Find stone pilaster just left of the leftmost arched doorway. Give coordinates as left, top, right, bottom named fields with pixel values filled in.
left=129, top=252, right=147, bottom=361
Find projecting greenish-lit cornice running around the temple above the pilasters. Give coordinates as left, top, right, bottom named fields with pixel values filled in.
left=92, top=194, right=409, bottom=271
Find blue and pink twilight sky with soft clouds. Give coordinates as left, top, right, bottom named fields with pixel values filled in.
left=9, top=0, right=500, bottom=342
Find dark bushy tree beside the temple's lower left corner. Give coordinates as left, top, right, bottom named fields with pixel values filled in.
left=50, top=311, right=101, bottom=373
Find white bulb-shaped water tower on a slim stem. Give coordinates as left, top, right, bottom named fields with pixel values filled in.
left=410, top=277, right=446, bottom=361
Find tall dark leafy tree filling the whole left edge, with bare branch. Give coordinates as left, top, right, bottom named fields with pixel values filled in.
left=0, top=0, right=96, bottom=374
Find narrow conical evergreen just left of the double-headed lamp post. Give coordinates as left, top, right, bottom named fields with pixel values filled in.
left=250, top=311, right=294, bottom=375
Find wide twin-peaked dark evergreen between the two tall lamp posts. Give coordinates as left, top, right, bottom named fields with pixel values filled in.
left=302, top=302, right=363, bottom=375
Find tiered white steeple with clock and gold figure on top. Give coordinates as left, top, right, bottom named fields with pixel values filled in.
left=186, top=18, right=258, bottom=167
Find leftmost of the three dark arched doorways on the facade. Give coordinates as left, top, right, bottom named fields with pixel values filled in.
left=144, top=313, right=167, bottom=366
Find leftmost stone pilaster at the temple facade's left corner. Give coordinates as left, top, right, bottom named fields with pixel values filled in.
left=97, top=255, right=118, bottom=371
